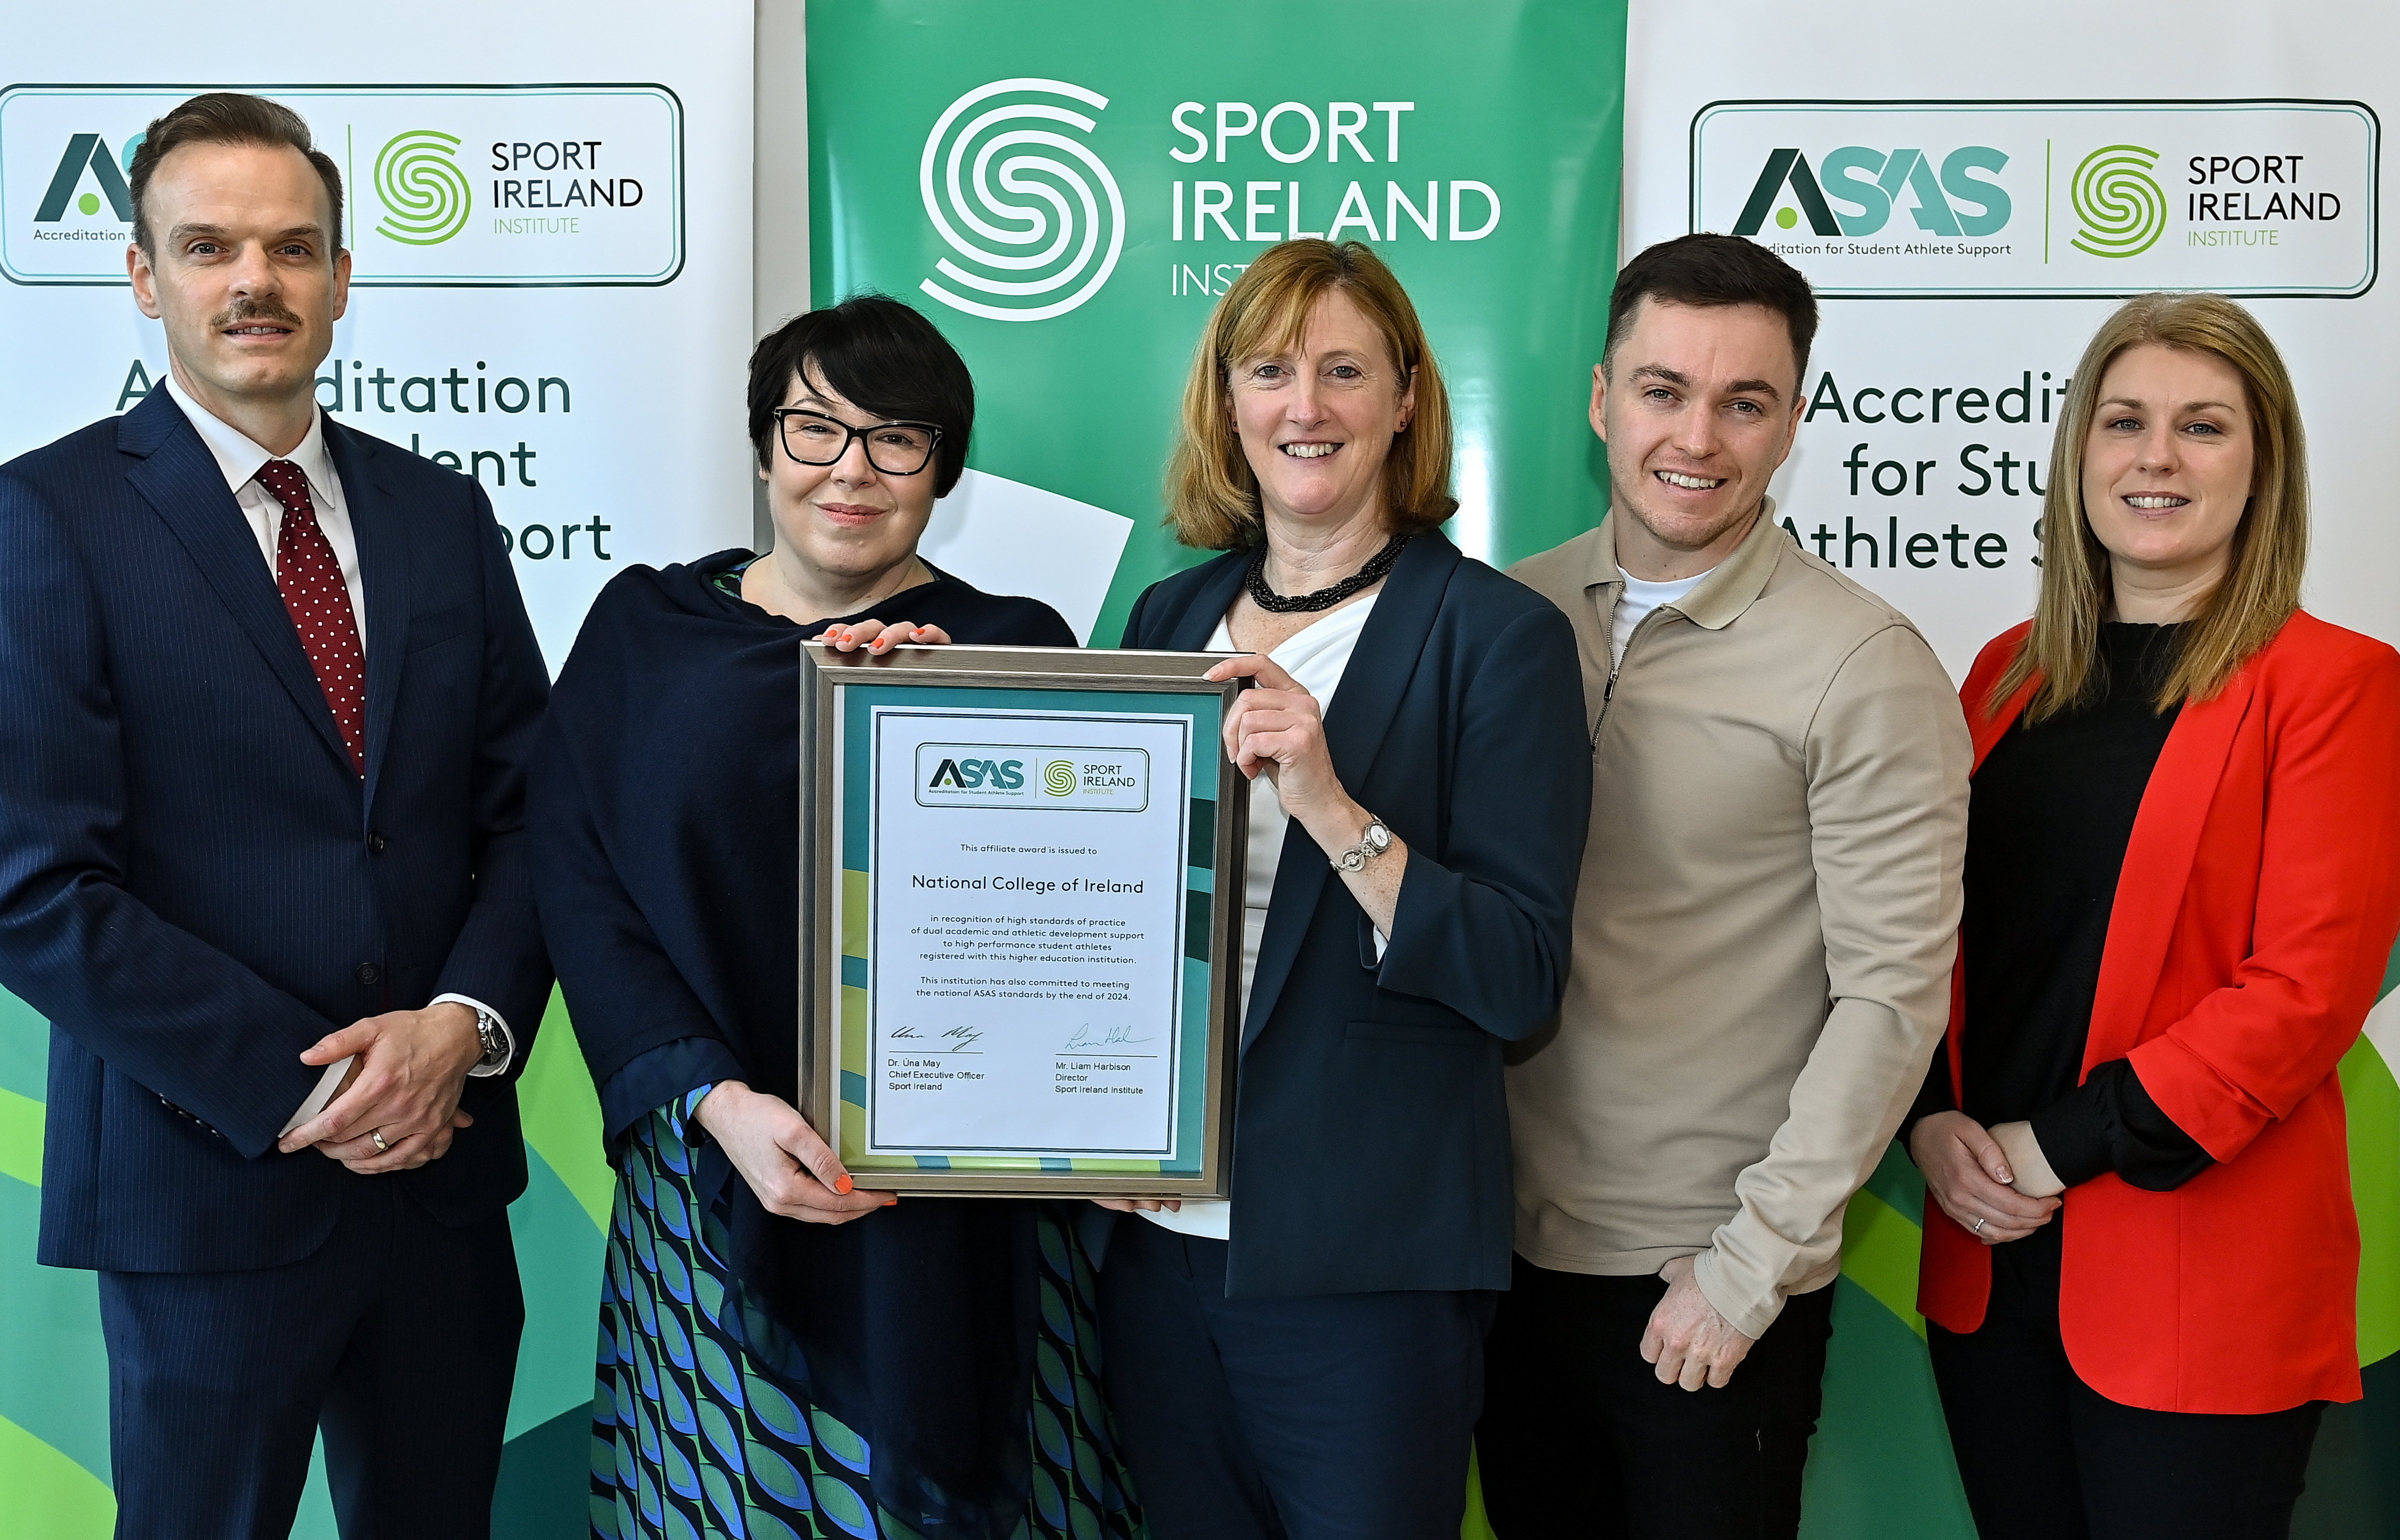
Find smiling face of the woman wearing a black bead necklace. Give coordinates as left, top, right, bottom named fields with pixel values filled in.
left=1227, top=288, right=1416, bottom=530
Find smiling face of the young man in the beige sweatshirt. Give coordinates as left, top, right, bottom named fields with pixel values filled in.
left=1591, top=297, right=1800, bottom=583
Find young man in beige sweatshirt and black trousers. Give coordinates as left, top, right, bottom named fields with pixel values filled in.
left=1478, top=235, right=1970, bottom=1540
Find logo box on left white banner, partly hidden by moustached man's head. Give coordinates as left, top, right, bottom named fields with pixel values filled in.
left=0, top=82, right=684, bottom=288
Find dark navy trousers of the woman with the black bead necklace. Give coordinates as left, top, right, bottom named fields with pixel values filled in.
left=1099, top=1216, right=1493, bottom=1540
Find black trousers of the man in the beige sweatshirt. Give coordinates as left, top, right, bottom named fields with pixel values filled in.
left=1476, top=1257, right=1834, bottom=1540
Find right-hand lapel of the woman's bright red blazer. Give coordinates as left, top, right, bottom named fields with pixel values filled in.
left=2083, top=669, right=2258, bottom=1075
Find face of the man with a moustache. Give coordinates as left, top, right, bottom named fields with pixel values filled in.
left=127, top=144, right=351, bottom=427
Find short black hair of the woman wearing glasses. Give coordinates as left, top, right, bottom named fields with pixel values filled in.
left=749, top=293, right=974, bottom=496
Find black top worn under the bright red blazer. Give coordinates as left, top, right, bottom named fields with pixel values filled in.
left=1910, top=621, right=2210, bottom=1199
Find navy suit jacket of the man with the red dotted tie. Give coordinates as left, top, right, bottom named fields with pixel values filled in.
left=0, top=391, right=550, bottom=1271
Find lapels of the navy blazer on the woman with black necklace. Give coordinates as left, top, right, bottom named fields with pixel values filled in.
left=1219, top=530, right=1461, bottom=1048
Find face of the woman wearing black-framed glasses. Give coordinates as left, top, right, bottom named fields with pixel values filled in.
left=759, top=367, right=941, bottom=587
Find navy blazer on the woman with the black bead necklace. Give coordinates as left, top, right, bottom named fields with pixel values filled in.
left=1126, top=530, right=1591, bottom=1295
